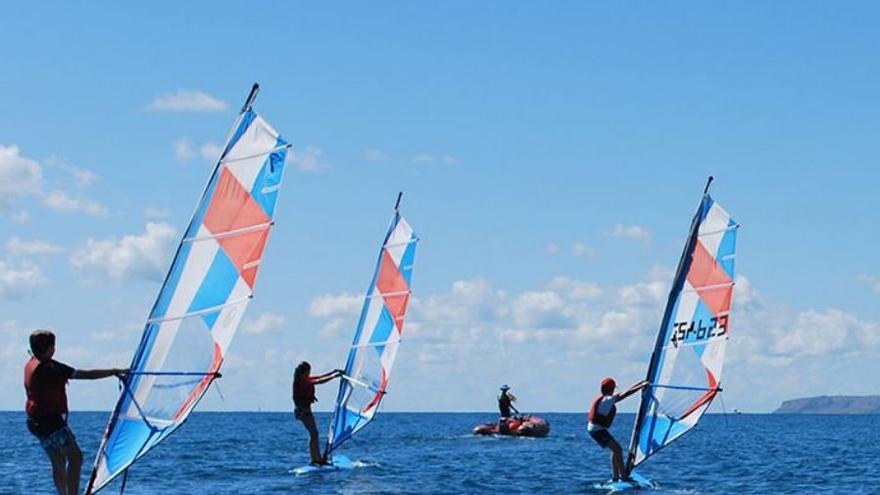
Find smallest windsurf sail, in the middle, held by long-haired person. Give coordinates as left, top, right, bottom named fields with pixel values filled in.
left=324, top=195, right=418, bottom=459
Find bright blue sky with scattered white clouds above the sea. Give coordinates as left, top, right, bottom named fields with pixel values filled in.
left=0, top=1, right=880, bottom=412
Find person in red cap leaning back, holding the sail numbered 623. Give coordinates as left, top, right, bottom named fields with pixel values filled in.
left=587, top=378, right=648, bottom=481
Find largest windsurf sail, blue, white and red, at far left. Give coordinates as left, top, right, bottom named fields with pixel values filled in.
left=86, top=84, right=290, bottom=493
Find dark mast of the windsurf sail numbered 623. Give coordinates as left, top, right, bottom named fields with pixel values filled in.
left=624, top=175, right=714, bottom=474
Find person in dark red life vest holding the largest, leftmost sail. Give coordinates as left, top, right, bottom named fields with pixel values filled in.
left=24, top=330, right=128, bottom=495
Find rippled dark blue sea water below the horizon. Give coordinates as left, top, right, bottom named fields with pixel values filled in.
left=0, top=412, right=880, bottom=495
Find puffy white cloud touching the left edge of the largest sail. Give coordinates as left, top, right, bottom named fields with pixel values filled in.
left=70, top=222, right=177, bottom=281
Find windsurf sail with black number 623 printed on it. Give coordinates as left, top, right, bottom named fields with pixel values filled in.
left=627, top=177, right=739, bottom=471
